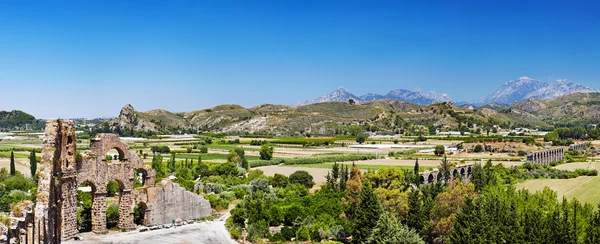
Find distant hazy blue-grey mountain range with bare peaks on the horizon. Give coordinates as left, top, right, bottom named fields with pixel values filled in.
left=295, top=76, right=600, bottom=106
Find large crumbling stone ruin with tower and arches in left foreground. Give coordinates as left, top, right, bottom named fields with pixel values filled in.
left=9, top=120, right=212, bottom=244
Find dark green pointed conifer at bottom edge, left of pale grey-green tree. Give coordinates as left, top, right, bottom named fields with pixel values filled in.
left=352, top=182, right=383, bottom=243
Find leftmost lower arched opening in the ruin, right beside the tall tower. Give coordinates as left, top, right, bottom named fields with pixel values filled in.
left=77, top=181, right=96, bottom=232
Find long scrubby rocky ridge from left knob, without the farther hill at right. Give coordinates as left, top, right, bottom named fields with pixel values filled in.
left=109, top=100, right=548, bottom=135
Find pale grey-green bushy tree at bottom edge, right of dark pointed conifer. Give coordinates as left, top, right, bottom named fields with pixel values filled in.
left=363, top=212, right=425, bottom=244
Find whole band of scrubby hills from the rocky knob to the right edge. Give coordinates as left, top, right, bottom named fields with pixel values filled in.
left=107, top=93, right=600, bottom=136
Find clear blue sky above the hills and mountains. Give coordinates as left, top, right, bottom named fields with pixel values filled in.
left=0, top=0, right=600, bottom=118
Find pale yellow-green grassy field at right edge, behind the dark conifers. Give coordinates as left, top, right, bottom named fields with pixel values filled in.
left=516, top=162, right=600, bottom=206
